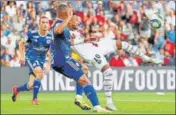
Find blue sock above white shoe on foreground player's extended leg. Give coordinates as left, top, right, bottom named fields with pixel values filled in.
left=84, top=84, right=99, bottom=106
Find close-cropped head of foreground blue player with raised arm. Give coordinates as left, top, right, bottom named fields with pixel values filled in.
left=56, top=4, right=68, bottom=20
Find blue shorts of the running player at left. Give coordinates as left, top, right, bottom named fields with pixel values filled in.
left=25, top=59, right=45, bottom=74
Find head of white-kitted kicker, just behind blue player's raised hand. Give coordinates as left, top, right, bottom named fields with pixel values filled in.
left=68, top=15, right=80, bottom=30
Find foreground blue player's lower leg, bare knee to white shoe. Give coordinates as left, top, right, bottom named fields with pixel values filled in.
left=77, top=74, right=110, bottom=112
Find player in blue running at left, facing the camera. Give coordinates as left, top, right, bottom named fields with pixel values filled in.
left=12, top=16, right=52, bottom=105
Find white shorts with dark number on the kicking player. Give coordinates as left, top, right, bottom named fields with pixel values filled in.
left=71, top=39, right=117, bottom=70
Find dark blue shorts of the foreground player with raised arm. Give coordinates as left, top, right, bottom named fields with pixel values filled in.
left=52, top=58, right=84, bottom=81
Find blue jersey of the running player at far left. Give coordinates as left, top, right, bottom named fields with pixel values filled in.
left=26, top=30, right=52, bottom=61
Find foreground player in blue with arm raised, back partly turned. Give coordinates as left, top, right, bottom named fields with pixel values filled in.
left=52, top=4, right=109, bottom=112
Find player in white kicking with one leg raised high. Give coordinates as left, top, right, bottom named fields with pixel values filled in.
left=70, top=16, right=162, bottom=110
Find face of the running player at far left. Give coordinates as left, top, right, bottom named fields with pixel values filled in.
left=40, top=18, right=49, bottom=31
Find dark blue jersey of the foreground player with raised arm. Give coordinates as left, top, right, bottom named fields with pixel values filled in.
left=52, top=19, right=71, bottom=65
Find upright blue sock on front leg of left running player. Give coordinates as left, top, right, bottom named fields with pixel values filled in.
left=33, top=80, right=41, bottom=99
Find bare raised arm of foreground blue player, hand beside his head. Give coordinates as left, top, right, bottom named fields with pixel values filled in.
left=54, top=8, right=73, bottom=34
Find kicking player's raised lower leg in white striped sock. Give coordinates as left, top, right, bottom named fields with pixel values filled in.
left=119, top=40, right=163, bottom=64
